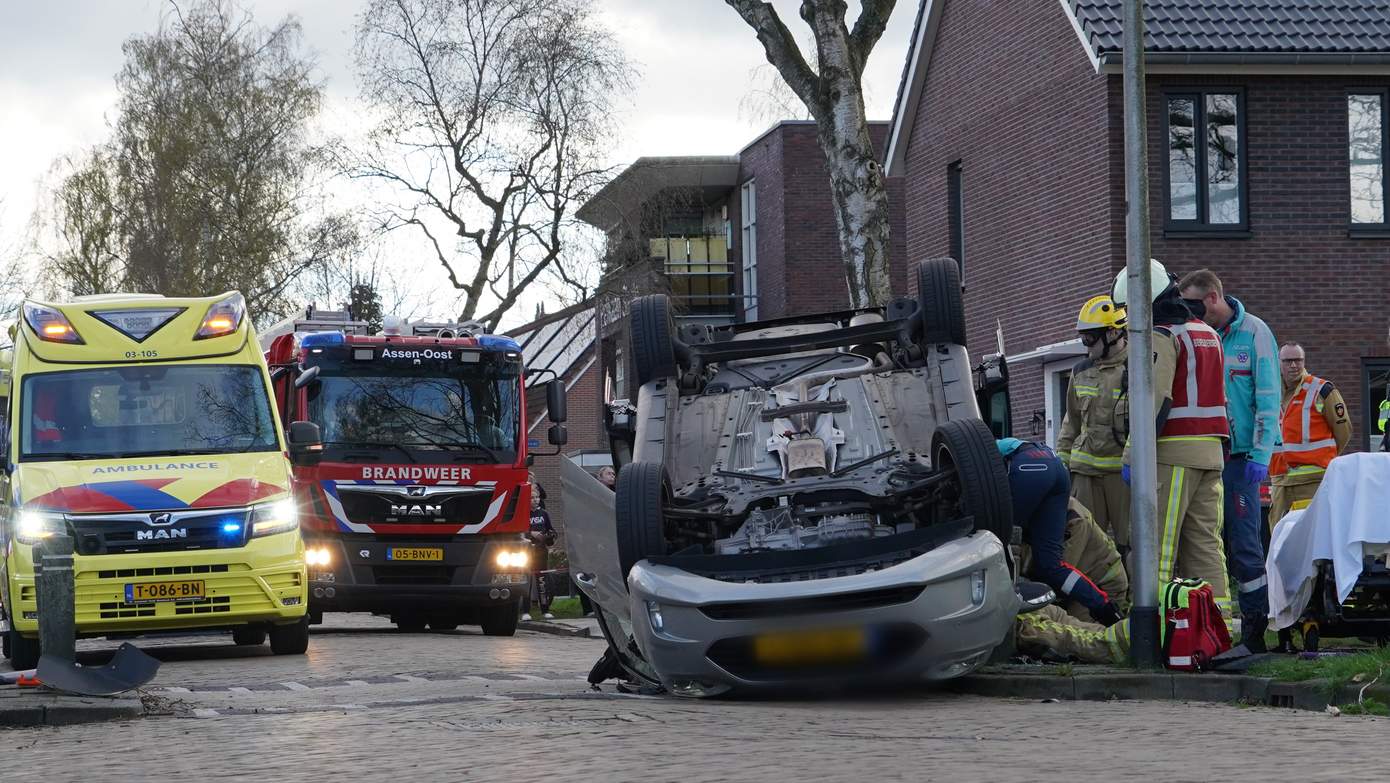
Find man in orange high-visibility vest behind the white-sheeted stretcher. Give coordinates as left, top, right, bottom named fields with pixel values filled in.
left=1269, top=342, right=1351, bottom=526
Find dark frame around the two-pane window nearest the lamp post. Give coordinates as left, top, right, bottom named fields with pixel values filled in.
left=1161, top=85, right=1250, bottom=239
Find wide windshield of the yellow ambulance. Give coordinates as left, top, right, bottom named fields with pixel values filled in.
left=19, top=364, right=279, bottom=460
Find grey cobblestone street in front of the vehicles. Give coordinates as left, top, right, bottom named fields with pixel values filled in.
left=0, top=616, right=1390, bottom=782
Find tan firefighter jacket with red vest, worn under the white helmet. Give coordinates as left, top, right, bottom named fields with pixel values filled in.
left=1125, top=318, right=1230, bottom=470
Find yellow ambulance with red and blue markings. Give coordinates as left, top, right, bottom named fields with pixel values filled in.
left=0, top=293, right=309, bottom=669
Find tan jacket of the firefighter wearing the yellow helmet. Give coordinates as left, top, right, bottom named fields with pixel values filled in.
left=1056, top=353, right=1129, bottom=476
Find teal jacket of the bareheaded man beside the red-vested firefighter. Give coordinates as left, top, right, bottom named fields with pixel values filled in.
left=1220, top=296, right=1282, bottom=465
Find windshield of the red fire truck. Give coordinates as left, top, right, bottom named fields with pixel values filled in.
left=309, top=363, right=520, bottom=463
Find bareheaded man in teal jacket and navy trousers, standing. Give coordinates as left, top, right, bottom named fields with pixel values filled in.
left=1177, top=270, right=1280, bottom=652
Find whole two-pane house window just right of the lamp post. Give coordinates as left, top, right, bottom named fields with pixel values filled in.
left=1166, top=90, right=1248, bottom=231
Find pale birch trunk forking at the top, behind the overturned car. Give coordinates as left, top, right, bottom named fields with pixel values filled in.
left=724, top=0, right=897, bottom=307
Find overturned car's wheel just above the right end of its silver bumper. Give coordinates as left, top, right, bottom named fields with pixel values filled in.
left=931, top=419, right=1013, bottom=555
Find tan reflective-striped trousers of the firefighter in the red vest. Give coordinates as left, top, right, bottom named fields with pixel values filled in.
left=1154, top=462, right=1232, bottom=626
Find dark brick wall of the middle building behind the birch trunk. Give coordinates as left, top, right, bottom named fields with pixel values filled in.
left=730, top=122, right=908, bottom=318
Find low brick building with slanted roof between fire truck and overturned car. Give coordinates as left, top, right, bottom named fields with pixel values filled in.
left=507, top=302, right=612, bottom=537
